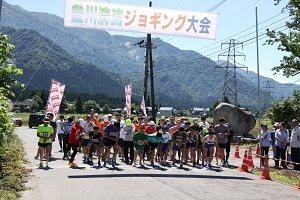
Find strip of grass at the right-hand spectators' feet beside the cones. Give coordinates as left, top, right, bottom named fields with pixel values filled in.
left=252, top=168, right=300, bottom=187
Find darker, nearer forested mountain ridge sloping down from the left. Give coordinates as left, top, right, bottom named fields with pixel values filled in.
left=1, top=27, right=123, bottom=96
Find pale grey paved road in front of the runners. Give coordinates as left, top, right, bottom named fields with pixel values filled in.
left=16, top=127, right=300, bottom=200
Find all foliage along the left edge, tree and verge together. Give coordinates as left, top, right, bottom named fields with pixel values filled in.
left=0, top=35, right=27, bottom=199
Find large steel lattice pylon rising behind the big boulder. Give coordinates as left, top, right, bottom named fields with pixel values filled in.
left=216, top=39, right=248, bottom=105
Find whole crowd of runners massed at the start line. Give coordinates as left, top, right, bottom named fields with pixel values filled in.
left=35, top=109, right=233, bottom=169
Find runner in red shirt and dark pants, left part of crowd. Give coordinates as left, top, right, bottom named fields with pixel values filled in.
left=68, top=120, right=83, bottom=167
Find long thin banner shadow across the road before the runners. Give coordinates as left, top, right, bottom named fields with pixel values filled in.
left=68, top=174, right=253, bottom=181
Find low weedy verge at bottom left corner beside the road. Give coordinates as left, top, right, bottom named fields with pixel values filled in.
left=0, top=134, right=30, bottom=199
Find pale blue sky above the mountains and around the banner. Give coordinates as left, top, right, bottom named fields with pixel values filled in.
left=6, top=0, right=300, bottom=83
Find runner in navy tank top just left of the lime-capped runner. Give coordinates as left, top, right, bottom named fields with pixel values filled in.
left=103, top=119, right=120, bottom=167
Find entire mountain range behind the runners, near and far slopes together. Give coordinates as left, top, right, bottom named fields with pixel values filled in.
left=1, top=3, right=300, bottom=110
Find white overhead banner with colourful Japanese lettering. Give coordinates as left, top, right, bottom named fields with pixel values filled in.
left=64, top=0, right=218, bottom=40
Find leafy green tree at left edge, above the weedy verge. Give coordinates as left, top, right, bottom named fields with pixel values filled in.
left=0, top=35, right=23, bottom=145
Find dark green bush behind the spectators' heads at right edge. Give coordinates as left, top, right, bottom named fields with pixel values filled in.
left=266, top=90, right=300, bottom=128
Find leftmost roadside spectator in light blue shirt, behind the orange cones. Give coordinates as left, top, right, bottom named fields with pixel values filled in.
left=258, top=124, right=271, bottom=165
